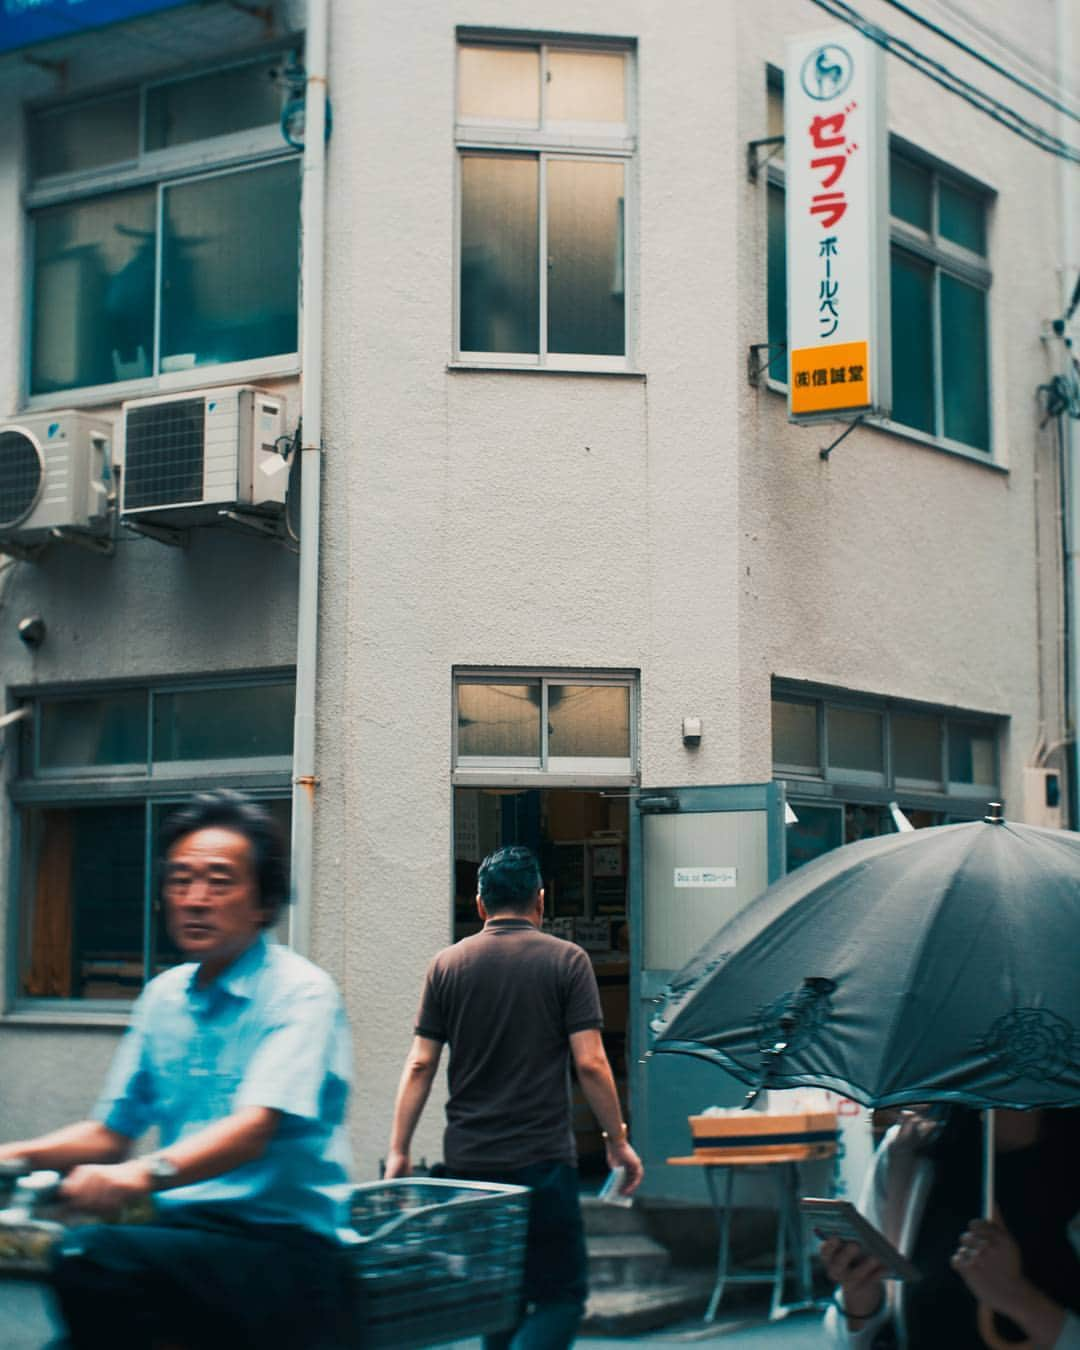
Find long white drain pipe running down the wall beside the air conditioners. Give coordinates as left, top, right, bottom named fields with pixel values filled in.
left=289, top=0, right=329, bottom=954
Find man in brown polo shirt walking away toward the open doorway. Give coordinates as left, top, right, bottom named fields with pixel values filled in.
left=386, top=845, right=643, bottom=1350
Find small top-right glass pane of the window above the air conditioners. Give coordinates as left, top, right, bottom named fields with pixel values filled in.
left=146, top=57, right=285, bottom=150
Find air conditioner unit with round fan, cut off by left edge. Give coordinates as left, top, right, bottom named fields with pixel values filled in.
left=0, top=412, right=113, bottom=549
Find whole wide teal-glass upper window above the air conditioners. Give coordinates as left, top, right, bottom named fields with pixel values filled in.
left=27, top=53, right=300, bottom=396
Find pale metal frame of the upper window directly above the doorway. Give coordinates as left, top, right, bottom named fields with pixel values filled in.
left=451, top=28, right=637, bottom=374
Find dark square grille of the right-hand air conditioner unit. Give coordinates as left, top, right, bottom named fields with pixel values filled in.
left=124, top=398, right=205, bottom=510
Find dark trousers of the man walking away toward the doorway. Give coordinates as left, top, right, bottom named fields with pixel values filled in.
left=447, top=1162, right=589, bottom=1350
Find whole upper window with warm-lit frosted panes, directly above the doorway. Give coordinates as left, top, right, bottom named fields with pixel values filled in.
left=456, top=39, right=632, bottom=369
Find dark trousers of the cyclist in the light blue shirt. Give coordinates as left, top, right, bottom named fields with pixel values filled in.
left=53, top=1219, right=358, bottom=1350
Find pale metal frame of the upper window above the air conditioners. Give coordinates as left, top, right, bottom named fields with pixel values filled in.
left=20, top=42, right=301, bottom=409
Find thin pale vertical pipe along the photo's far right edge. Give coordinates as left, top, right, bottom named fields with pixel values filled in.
left=1057, top=0, right=1080, bottom=829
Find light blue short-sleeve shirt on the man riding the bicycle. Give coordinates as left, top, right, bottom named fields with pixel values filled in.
left=93, top=937, right=351, bottom=1237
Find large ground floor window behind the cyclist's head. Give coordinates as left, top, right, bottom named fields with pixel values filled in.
left=8, top=675, right=293, bottom=1007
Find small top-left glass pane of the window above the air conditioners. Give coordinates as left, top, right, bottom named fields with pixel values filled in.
left=30, top=90, right=139, bottom=178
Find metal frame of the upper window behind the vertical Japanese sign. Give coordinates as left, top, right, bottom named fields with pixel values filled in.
left=761, top=76, right=1004, bottom=470
